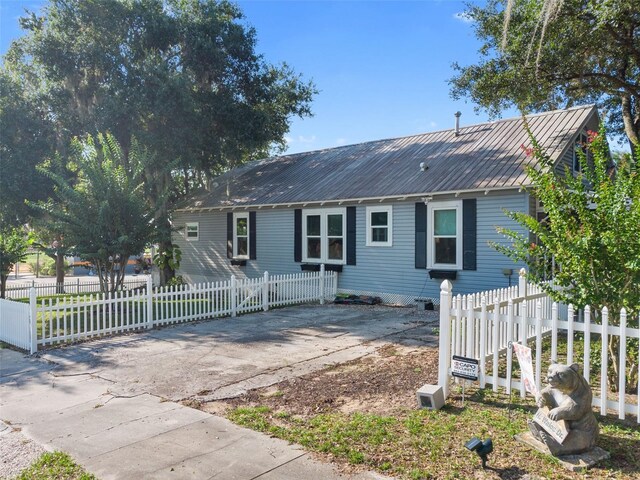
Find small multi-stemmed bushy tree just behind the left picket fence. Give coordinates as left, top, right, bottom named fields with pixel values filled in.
left=36, top=134, right=155, bottom=291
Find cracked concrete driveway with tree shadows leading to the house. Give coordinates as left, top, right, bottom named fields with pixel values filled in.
left=0, top=306, right=435, bottom=480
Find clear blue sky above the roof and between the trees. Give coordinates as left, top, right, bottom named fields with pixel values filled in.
left=0, top=0, right=518, bottom=153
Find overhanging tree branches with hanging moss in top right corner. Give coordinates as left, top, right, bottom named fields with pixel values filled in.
left=450, top=0, right=640, bottom=148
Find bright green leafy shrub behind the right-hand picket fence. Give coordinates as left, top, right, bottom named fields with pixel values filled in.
left=494, top=124, right=640, bottom=323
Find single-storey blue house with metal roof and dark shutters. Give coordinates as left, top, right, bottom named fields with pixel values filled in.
left=173, top=106, right=598, bottom=303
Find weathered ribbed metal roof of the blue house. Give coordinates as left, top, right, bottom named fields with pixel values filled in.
left=183, top=105, right=596, bottom=210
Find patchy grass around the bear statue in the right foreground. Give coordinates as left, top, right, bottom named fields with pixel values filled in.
left=227, top=390, right=640, bottom=479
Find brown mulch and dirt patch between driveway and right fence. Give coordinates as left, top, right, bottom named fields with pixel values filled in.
left=201, top=345, right=438, bottom=416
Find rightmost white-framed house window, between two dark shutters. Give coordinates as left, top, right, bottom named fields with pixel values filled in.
left=427, top=201, right=462, bottom=269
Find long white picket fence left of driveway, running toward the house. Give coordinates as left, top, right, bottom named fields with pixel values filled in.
left=0, top=266, right=338, bottom=353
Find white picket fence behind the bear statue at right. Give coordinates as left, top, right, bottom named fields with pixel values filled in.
left=438, top=270, right=640, bottom=423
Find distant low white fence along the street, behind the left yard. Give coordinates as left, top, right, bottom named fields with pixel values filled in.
left=5, top=275, right=147, bottom=299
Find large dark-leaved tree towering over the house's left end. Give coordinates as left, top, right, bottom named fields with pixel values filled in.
left=3, top=0, right=315, bottom=284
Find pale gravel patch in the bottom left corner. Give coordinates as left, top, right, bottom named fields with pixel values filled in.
left=0, top=421, right=46, bottom=479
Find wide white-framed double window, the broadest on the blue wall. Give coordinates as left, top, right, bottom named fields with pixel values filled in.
left=302, top=208, right=346, bottom=264
